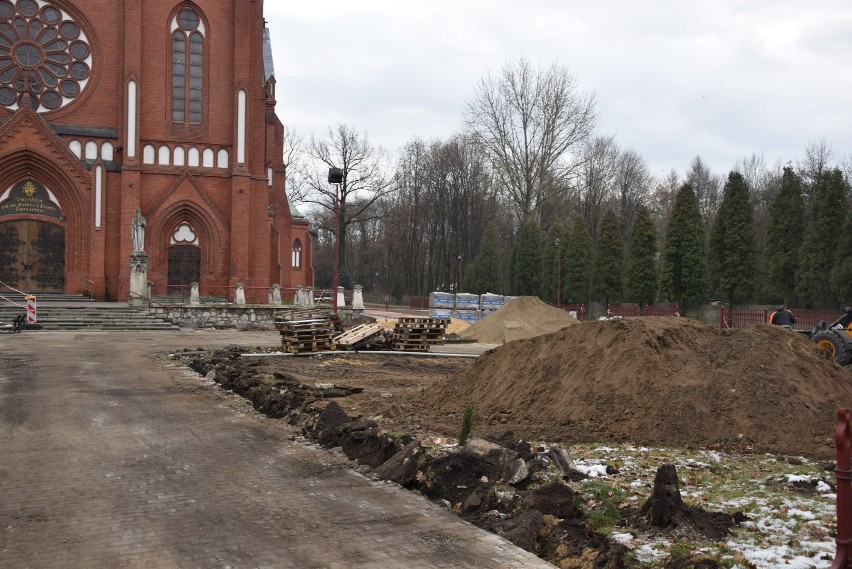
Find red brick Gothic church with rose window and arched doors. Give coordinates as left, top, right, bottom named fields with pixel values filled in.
left=0, top=0, right=313, bottom=301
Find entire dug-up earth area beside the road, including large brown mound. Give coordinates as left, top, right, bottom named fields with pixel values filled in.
left=174, top=312, right=852, bottom=568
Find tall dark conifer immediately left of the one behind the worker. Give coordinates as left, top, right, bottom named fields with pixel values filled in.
left=707, top=172, right=755, bottom=306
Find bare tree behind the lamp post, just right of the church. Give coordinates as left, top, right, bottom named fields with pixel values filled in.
left=303, top=124, right=395, bottom=282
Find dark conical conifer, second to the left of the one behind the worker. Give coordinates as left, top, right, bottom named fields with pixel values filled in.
left=660, top=184, right=707, bottom=314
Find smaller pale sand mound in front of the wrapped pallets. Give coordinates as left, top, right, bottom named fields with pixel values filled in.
left=464, top=296, right=579, bottom=344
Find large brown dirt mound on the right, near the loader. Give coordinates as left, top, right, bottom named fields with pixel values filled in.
left=424, top=317, right=852, bottom=458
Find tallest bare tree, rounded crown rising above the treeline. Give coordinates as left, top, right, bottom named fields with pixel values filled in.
left=465, top=58, right=597, bottom=219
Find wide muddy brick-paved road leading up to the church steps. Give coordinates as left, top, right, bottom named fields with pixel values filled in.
left=0, top=331, right=552, bottom=569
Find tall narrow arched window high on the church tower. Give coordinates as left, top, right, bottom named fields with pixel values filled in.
left=172, top=8, right=204, bottom=124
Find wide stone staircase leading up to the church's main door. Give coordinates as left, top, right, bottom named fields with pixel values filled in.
left=0, top=294, right=180, bottom=332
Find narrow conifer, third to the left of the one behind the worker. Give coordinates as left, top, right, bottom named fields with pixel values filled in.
left=626, top=206, right=657, bottom=307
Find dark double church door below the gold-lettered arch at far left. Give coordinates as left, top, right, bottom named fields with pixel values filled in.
left=0, top=220, right=65, bottom=293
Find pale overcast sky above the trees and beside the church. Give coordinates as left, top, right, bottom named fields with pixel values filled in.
left=265, top=0, right=852, bottom=179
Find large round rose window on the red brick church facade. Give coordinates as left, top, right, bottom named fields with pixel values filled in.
left=0, top=0, right=92, bottom=112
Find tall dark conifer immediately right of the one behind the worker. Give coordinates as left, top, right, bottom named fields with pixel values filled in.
left=796, top=168, right=849, bottom=308
